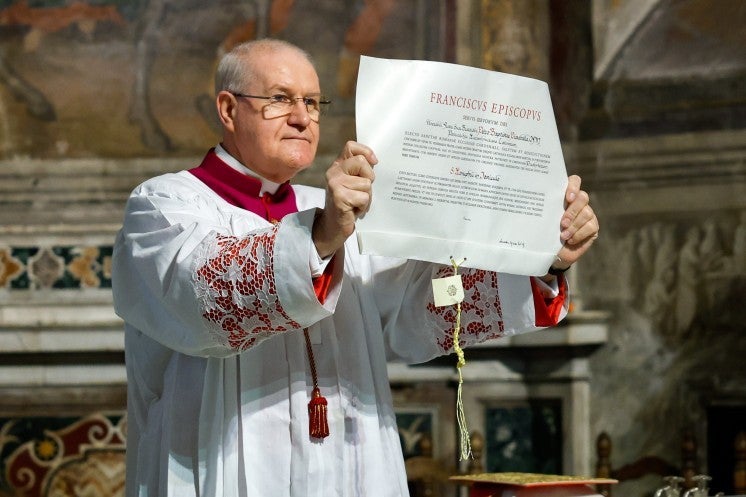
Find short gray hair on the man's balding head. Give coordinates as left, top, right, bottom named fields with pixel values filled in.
left=215, top=38, right=314, bottom=95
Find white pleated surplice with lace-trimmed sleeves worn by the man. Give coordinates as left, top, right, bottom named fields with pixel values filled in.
left=113, top=161, right=566, bottom=497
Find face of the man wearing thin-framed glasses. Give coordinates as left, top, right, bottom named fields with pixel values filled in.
left=228, top=50, right=321, bottom=183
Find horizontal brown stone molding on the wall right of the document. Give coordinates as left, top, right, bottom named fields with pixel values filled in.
left=565, top=130, right=746, bottom=213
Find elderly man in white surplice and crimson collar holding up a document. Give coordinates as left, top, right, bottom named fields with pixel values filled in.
left=113, top=40, right=598, bottom=497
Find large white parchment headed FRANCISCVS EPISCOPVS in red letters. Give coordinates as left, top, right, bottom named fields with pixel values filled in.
left=355, top=57, right=567, bottom=275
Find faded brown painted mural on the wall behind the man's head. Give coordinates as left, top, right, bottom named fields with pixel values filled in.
left=0, top=0, right=443, bottom=159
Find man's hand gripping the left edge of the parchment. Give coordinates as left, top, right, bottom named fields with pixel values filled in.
left=312, top=141, right=378, bottom=258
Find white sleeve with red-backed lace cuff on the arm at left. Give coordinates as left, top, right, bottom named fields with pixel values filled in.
left=112, top=175, right=341, bottom=356
